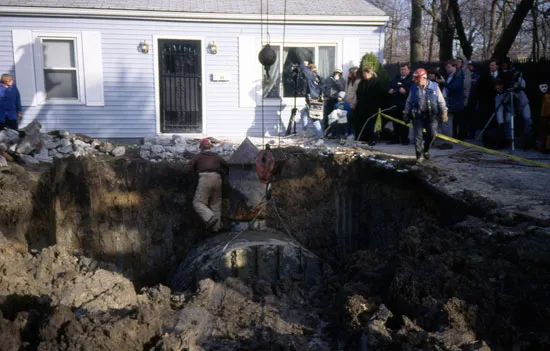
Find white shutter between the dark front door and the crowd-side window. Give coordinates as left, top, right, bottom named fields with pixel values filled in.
left=239, top=36, right=262, bottom=107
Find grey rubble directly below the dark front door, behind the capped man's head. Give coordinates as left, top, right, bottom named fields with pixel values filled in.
left=139, top=135, right=235, bottom=162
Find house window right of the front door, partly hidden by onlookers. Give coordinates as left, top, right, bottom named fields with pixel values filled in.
left=263, top=44, right=336, bottom=98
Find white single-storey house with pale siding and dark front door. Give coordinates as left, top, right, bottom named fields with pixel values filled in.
left=0, top=0, right=388, bottom=138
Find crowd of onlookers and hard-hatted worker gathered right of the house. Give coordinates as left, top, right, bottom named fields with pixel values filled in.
left=301, top=58, right=532, bottom=160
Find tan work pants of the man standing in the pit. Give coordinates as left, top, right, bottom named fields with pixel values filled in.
left=193, top=172, right=222, bottom=232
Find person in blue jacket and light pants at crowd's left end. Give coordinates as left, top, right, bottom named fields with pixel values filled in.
left=300, top=61, right=324, bottom=138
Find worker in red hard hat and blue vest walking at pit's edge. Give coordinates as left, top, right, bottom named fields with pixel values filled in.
left=403, top=68, right=448, bottom=163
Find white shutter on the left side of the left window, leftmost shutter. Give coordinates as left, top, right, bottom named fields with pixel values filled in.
left=12, top=29, right=36, bottom=106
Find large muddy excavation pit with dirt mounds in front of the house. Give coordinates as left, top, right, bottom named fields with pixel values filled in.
left=0, top=149, right=550, bottom=350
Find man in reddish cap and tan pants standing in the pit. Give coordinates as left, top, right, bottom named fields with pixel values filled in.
left=186, top=138, right=229, bottom=233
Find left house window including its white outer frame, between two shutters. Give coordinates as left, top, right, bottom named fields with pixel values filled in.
left=34, top=33, right=86, bottom=104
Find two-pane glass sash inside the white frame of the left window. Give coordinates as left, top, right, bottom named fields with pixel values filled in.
left=42, top=39, right=78, bottom=100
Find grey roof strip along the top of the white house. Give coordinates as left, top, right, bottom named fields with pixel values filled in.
left=1, top=0, right=386, bottom=16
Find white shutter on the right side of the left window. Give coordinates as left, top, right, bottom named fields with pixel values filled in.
left=82, top=32, right=105, bottom=106
